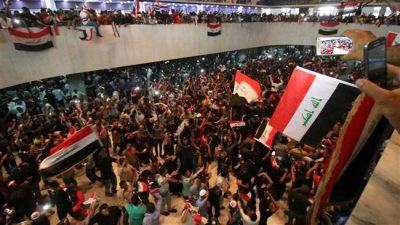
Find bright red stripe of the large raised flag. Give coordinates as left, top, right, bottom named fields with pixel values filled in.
left=270, top=68, right=315, bottom=132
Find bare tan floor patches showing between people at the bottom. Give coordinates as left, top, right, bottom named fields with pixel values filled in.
left=39, top=158, right=287, bottom=225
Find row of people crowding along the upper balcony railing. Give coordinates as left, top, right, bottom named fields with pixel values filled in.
left=0, top=2, right=400, bottom=28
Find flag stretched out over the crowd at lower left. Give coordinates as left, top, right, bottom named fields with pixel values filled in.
left=39, top=126, right=102, bottom=177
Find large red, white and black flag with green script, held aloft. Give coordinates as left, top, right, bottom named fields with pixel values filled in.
left=270, top=67, right=360, bottom=146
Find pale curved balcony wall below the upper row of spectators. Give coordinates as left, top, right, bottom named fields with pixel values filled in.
left=0, top=22, right=400, bottom=88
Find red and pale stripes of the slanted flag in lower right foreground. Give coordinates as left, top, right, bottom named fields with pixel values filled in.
left=307, top=94, right=382, bottom=224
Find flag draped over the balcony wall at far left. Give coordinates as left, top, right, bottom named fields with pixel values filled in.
left=8, top=27, right=54, bottom=51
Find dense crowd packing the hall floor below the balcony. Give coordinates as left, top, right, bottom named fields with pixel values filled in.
left=0, top=46, right=362, bottom=225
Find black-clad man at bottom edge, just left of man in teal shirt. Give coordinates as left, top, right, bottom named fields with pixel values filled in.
left=89, top=204, right=121, bottom=225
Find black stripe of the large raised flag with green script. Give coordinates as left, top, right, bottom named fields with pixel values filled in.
left=301, top=83, right=360, bottom=146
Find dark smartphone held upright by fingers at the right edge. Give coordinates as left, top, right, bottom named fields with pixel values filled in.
left=364, top=37, right=386, bottom=87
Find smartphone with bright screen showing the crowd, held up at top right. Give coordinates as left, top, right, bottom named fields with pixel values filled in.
left=316, top=37, right=353, bottom=55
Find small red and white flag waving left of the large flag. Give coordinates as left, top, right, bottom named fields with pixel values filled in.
left=233, top=70, right=262, bottom=103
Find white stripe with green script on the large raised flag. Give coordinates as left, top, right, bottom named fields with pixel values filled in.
left=283, top=75, right=338, bottom=141
